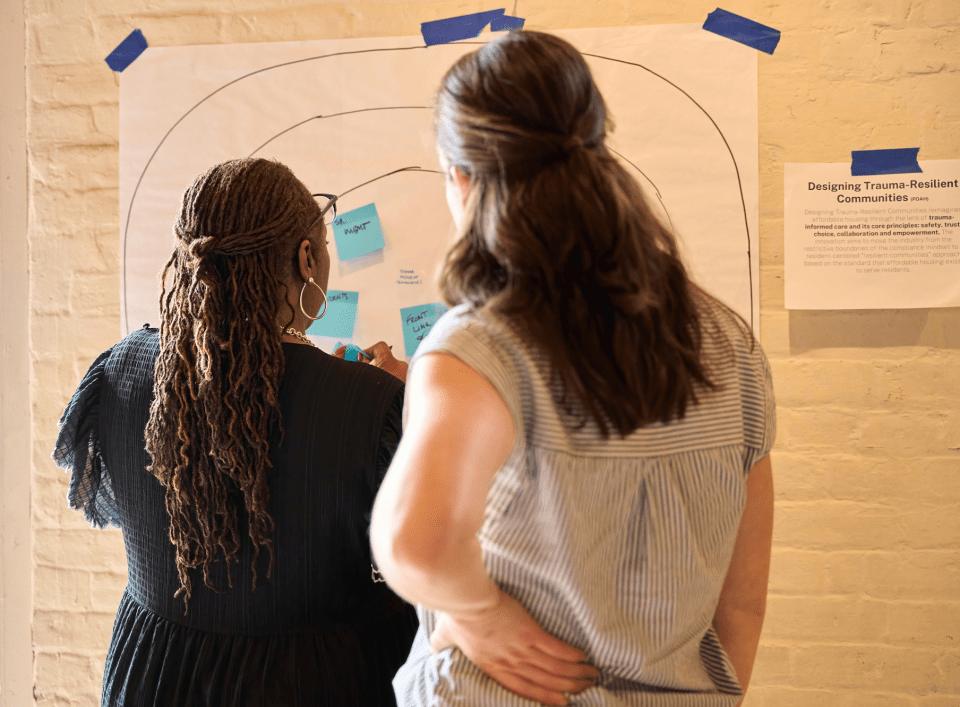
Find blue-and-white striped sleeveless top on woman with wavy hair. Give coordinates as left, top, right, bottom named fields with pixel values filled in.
left=394, top=306, right=775, bottom=707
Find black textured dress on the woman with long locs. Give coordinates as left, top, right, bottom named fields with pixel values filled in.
left=54, top=328, right=417, bottom=707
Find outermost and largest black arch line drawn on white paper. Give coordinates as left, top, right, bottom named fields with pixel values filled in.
left=121, top=42, right=754, bottom=330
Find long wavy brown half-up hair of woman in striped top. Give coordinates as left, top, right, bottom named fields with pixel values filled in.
left=435, top=32, right=745, bottom=437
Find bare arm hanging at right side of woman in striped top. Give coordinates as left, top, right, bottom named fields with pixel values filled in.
left=713, top=456, right=773, bottom=704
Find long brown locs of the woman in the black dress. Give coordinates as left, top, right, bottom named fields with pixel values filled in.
left=145, top=159, right=322, bottom=609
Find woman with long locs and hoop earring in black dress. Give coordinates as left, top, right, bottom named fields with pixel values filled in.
left=54, top=159, right=417, bottom=707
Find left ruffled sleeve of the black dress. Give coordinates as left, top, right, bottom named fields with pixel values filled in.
left=53, top=349, right=120, bottom=528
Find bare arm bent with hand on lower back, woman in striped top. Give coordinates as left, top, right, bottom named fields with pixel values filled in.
left=370, top=353, right=597, bottom=705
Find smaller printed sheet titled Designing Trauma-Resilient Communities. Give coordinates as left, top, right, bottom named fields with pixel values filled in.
left=784, top=160, right=960, bottom=309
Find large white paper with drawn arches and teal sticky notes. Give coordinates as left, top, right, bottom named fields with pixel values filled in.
left=120, top=25, right=759, bottom=354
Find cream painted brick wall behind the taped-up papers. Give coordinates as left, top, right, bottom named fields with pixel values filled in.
left=9, top=0, right=960, bottom=707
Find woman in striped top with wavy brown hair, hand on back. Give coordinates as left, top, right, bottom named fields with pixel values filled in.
left=371, top=32, right=775, bottom=707
